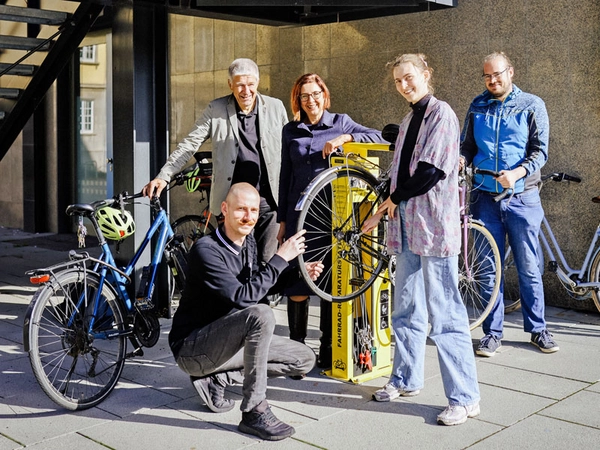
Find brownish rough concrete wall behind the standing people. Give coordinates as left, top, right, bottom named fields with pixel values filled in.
left=166, top=0, right=600, bottom=308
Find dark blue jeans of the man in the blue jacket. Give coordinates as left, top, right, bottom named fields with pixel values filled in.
left=470, top=189, right=546, bottom=339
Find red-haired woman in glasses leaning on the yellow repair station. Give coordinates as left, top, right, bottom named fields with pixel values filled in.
left=277, top=73, right=385, bottom=368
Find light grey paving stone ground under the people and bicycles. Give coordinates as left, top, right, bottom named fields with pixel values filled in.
left=0, top=227, right=600, bottom=450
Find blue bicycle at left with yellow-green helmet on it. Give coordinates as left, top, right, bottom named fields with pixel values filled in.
left=23, top=193, right=186, bottom=410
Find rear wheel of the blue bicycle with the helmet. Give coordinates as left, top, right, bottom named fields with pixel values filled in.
left=25, top=269, right=127, bottom=410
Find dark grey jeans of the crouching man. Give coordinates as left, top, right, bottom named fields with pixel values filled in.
left=177, top=304, right=316, bottom=412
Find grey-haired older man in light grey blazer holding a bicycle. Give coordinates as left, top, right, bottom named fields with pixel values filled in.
left=142, top=58, right=288, bottom=261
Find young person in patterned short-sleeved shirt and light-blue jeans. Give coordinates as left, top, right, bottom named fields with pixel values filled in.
left=363, top=54, right=480, bottom=425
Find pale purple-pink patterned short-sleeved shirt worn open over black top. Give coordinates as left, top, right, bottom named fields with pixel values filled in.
left=387, top=97, right=461, bottom=257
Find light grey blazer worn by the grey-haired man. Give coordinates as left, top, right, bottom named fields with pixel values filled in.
left=157, top=94, right=288, bottom=214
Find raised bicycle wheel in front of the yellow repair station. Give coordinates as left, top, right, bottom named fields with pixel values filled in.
left=298, top=167, right=389, bottom=302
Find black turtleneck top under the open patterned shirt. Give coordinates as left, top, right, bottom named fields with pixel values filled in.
left=390, top=94, right=445, bottom=205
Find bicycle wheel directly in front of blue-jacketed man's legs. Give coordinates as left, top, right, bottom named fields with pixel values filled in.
left=458, top=222, right=502, bottom=330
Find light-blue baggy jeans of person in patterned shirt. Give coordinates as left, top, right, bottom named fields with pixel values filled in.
left=390, top=202, right=479, bottom=406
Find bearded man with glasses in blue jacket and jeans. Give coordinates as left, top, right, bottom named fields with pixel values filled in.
left=461, top=53, right=558, bottom=357
